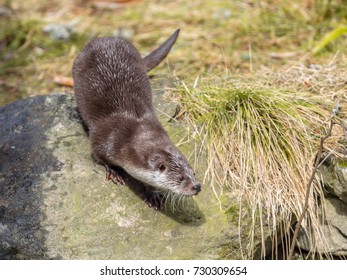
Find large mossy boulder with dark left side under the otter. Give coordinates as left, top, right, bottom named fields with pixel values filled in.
left=0, top=94, right=240, bottom=259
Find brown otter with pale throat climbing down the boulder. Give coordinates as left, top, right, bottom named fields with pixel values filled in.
left=72, top=29, right=201, bottom=210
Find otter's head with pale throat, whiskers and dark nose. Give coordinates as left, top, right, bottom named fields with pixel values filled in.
left=124, top=145, right=201, bottom=196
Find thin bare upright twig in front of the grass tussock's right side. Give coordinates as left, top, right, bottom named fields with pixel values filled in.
left=287, top=120, right=335, bottom=260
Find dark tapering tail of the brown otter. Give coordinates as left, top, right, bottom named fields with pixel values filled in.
left=143, top=29, right=180, bottom=72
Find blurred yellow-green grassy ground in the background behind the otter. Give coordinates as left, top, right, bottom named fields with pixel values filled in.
left=0, top=0, right=347, bottom=104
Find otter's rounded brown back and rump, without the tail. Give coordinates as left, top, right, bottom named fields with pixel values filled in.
left=73, top=37, right=152, bottom=125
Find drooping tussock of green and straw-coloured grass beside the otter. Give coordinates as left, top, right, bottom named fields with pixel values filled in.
left=172, top=60, right=346, bottom=258
